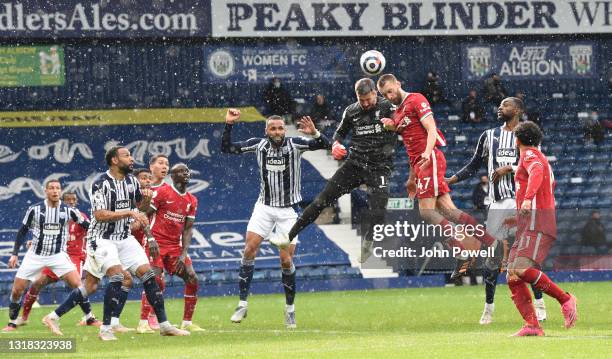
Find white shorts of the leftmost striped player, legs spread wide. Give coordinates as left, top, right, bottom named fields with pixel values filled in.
left=15, top=251, right=76, bottom=282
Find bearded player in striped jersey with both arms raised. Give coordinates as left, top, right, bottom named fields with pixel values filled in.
left=221, top=109, right=329, bottom=329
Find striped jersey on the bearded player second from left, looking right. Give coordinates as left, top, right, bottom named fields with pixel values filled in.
left=87, top=171, right=142, bottom=240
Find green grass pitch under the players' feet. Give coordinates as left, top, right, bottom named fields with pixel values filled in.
left=0, top=282, right=612, bottom=359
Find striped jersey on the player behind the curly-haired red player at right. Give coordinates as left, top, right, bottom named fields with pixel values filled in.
left=455, top=125, right=519, bottom=202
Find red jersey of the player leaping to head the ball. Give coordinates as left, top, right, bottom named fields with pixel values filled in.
left=393, top=92, right=446, bottom=167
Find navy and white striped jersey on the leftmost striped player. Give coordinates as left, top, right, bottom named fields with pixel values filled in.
left=13, top=200, right=89, bottom=256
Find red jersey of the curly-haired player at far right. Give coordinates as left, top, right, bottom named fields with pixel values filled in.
left=514, top=148, right=557, bottom=238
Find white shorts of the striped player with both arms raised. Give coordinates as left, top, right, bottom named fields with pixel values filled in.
left=247, top=202, right=297, bottom=239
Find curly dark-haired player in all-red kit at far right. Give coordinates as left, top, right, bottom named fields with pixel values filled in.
left=507, top=121, right=578, bottom=336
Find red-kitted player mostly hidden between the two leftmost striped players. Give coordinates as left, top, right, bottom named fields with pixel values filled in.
left=17, top=192, right=102, bottom=327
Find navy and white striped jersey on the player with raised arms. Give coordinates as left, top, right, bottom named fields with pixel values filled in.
left=221, top=125, right=329, bottom=207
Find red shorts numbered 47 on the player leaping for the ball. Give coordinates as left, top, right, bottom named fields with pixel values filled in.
left=412, top=148, right=450, bottom=198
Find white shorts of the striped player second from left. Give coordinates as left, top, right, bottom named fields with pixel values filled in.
left=83, top=236, right=149, bottom=279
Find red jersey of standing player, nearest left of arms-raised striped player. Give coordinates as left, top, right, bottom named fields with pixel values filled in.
left=151, top=185, right=198, bottom=247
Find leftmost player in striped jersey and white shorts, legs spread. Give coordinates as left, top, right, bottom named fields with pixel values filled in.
left=2, top=179, right=93, bottom=332
